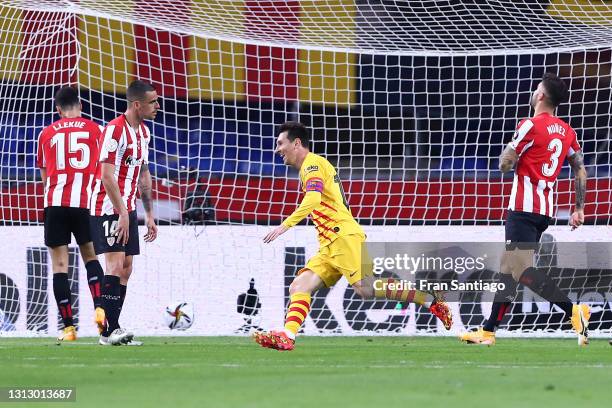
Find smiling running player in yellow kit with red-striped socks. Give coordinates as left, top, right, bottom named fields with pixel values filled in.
left=254, top=122, right=452, bottom=350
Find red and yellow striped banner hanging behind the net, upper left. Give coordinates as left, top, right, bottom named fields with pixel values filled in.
left=0, top=0, right=356, bottom=105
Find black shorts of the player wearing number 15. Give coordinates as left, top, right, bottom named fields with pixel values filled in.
left=45, top=207, right=91, bottom=248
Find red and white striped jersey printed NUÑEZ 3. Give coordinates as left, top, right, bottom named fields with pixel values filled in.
left=508, top=113, right=580, bottom=217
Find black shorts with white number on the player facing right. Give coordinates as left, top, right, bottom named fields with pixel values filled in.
left=89, top=211, right=140, bottom=255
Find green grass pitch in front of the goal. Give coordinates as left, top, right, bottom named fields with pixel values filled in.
left=0, top=337, right=612, bottom=408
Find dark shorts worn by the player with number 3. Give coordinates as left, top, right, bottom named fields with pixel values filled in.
left=505, top=210, right=551, bottom=250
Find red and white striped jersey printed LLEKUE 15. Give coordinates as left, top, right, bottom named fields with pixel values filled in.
left=36, top=118, right=102, bottom=208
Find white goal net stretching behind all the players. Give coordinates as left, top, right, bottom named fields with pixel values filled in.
left=0, top=0, right=612, bottom=335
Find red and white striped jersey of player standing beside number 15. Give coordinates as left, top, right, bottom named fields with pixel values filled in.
left=91, top=115, right=151, bottom=216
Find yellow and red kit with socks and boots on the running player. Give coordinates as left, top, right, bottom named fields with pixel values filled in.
left=274, top=152, right=452, bottom=342
